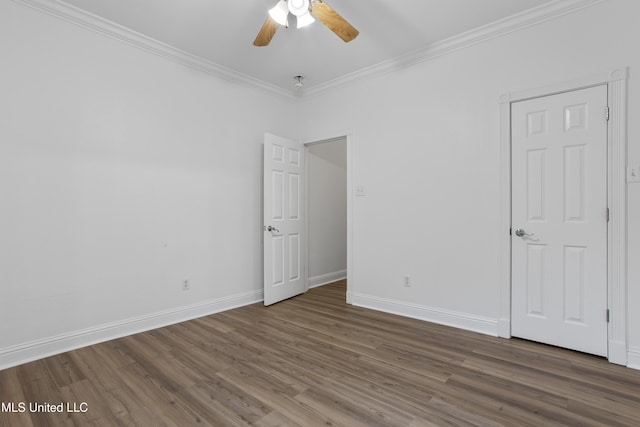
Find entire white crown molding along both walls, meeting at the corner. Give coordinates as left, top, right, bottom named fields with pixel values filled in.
left=12, top=0, right=607, bottom=99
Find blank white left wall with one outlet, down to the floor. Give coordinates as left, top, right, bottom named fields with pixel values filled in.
left=0, top=0, right=291, bottom=369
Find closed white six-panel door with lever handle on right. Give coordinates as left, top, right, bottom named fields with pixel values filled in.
left=511, top=86, right=607, bottom=356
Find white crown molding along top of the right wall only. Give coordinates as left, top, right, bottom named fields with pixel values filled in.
left=305, top=0, right=607, bottom=96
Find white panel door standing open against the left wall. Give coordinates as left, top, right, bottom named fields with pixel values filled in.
left=263, top=134, right=306, bottom=305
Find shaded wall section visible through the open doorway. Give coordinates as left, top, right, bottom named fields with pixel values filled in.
left=307, top=138, right=347, bottom=286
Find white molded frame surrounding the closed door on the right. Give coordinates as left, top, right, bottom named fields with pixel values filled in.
left=498, top=67, right=628, bottom=365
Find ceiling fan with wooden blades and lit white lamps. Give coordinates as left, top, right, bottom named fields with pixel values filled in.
left=253, top=0, right=359, bottom=46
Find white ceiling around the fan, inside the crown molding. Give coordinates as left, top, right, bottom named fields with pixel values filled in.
left=55, top=0, right=566, bottom=91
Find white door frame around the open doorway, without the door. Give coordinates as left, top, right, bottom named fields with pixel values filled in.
left=300, top=129, right=356, bottom=304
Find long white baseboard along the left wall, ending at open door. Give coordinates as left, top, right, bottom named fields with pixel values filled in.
left=0, top=290, right=263, bottom=370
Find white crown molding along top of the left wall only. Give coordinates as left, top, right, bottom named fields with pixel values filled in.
left=13, top=0, right=293, bottom=98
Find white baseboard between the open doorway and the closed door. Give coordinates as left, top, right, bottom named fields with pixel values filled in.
left=352, top=293, right=498, bottom=336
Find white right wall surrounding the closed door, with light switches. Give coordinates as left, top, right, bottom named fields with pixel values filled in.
left=300, top=0, right=640, bottom=366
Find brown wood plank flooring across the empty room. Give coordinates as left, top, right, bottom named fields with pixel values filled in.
left=0, top=282, right=640, bottom=427
